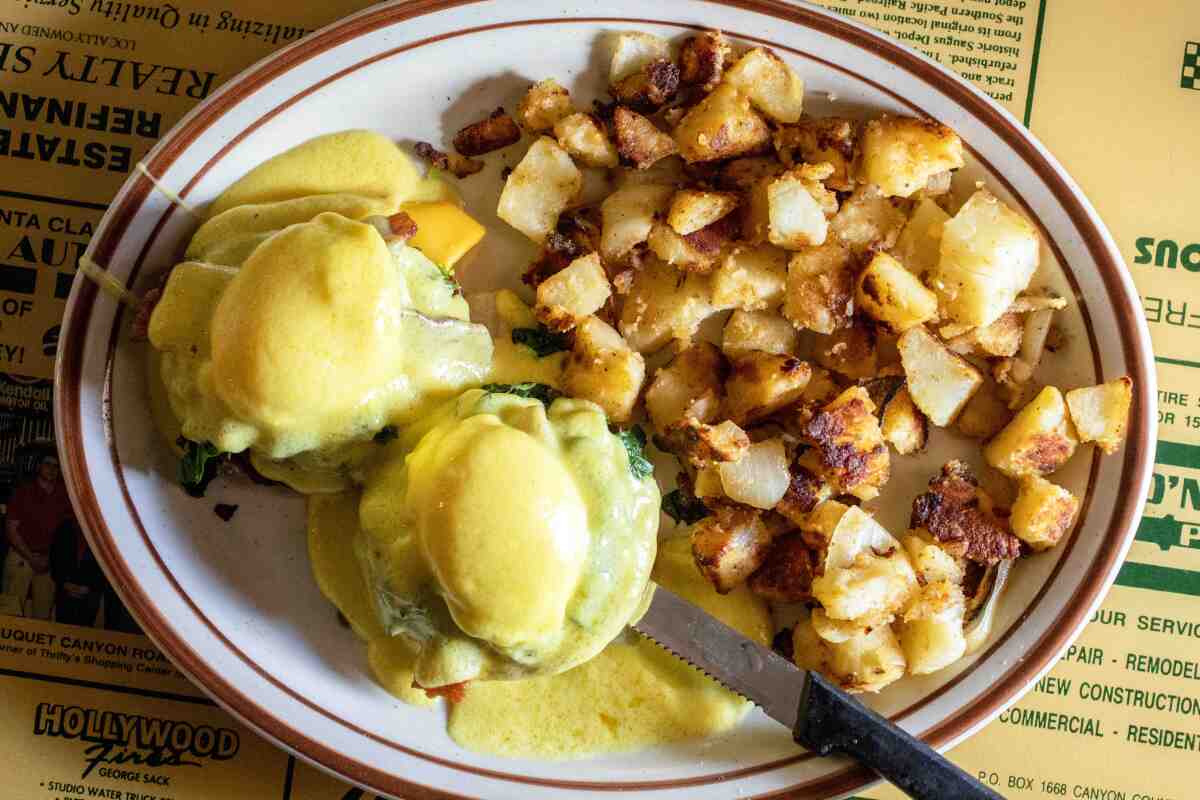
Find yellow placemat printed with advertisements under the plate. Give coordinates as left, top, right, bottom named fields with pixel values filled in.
left=0, top=0, right=1185, bottom=800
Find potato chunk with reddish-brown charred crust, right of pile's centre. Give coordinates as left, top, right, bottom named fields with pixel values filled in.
left=804, top=386, right=892, bottom=500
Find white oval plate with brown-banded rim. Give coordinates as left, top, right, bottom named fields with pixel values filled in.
left=55, top=0, right=1154, bottom=800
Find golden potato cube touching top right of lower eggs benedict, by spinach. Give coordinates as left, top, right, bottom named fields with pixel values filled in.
left=563, top=317, right=646, bottom=422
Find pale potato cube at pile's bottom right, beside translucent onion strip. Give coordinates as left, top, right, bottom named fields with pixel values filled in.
left=898, top=581, right=967, bottom=675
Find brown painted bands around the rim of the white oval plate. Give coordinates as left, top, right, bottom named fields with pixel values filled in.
left=55, top=0, right=1152, bottom=799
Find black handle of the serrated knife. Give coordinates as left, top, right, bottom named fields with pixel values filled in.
left=792, top=672, right=1004, bottom=800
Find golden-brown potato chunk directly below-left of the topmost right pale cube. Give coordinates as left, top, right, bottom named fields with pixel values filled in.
left=674, top=83, right=770, bottom=163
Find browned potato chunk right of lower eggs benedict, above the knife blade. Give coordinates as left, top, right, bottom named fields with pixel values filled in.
left=691, top=505, right=770, bottom=595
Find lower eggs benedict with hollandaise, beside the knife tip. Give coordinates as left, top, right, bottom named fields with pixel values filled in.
left=355, top=390, right=659, bottom=687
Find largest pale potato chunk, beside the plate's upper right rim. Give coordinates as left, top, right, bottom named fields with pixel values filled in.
left=930, top=190, right=1040, bottom=325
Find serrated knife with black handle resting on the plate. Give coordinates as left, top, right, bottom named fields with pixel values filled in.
left=634, top=587, right=1003, bottom=800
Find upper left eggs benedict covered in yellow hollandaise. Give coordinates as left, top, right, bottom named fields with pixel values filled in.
left=148, top=131, right=492, bottom=493
